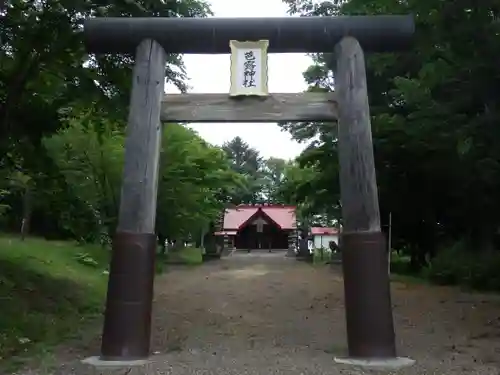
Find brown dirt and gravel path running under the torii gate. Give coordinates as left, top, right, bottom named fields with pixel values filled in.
left=25, top=253, right=500, bottom=375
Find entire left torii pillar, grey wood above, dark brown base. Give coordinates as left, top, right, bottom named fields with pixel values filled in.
left=101, top=40, right=166, bottom=360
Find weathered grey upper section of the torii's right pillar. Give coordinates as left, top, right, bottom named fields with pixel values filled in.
left=335, top=37, right=380, bottom=232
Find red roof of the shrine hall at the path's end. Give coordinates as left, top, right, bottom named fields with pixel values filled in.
left=223, top=204, right=297, bottom=230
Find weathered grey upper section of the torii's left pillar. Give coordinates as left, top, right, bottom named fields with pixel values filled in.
left=117, top=40, right=166, bottom=233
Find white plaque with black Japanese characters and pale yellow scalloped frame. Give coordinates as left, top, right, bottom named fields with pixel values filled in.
left=229, top=40, right=269, bottom=96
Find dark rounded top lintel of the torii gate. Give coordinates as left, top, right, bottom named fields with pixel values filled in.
left=84, top=15, right=415, bottom=54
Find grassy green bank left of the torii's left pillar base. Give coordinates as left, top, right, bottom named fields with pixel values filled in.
left=0, top=237, right=109, bottom=372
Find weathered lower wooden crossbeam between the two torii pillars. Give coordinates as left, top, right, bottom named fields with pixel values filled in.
left=161, top=93, right=337, bottom=122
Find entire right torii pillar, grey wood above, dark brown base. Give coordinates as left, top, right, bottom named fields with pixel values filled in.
left=335, top=37, right=396, bottom=358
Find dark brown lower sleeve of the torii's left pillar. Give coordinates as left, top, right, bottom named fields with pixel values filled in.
left=101, top=232, right=156, bottom=361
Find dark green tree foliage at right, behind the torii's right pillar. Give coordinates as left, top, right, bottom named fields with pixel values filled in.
left=282, top=0, right=500, bottom=270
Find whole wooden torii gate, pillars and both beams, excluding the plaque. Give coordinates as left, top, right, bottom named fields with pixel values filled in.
left=84, top=15, right=414, bottom=361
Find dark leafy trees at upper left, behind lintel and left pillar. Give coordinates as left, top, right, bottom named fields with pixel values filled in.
left=0, top=0, right=210, bottom=240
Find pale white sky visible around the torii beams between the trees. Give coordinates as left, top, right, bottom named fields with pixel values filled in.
left=166, top=0, right=311, bottom=159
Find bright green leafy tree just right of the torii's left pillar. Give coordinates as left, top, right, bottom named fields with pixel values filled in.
left=157, top=124, right=242, bottom=238
